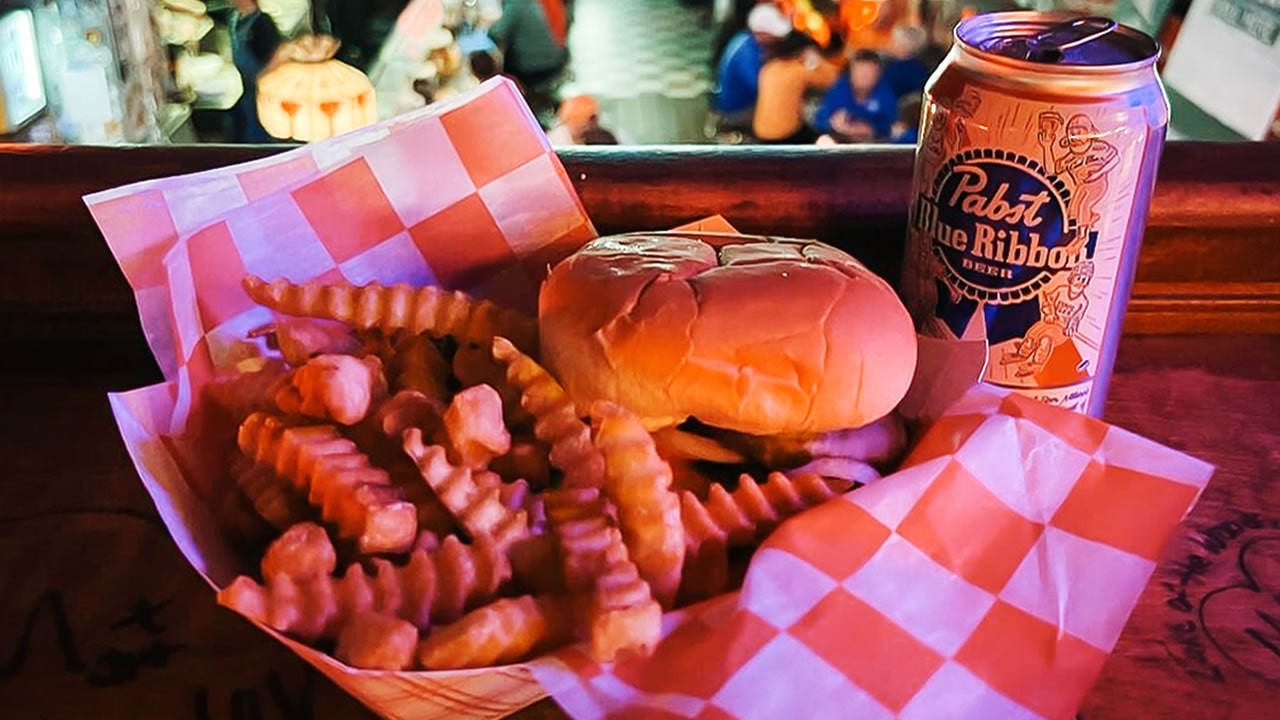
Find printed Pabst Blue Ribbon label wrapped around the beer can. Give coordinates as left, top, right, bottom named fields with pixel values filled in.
left=904, top=86, right=1149, bottom=411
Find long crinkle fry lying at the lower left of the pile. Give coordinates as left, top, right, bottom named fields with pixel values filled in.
left=218, top=536, right=511, bottom=641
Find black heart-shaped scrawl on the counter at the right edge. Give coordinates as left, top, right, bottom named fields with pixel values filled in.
left=1158, top=512, right=1280, bottom=684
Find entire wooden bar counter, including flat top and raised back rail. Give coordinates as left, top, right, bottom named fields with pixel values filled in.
left=0, top=142, right=1280, bottom=720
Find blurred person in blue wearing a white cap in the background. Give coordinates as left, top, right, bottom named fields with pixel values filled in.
left=714, top=5, right=791, bottom=129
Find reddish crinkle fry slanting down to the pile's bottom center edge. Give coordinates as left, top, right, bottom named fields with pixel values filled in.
left=547, top=488, right=662, bottom=662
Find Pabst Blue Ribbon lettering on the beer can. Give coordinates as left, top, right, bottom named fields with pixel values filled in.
left=915, top=165, right=1085, bottom=279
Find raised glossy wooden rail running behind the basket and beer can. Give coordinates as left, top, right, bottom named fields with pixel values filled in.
left=0, top=142, right=1280, bottom=365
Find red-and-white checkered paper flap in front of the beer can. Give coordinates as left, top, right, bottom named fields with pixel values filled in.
left=532, top=387, right=1212, bottom=720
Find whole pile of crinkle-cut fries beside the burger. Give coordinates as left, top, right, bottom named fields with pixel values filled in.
left=206, top=277, right=901, bottom=670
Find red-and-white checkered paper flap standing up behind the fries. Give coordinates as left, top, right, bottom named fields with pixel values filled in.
left=84, top=78, right=595, bottom=380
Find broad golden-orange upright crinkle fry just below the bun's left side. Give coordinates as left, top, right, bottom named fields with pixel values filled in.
left=591, top=402, right=685, bottom=609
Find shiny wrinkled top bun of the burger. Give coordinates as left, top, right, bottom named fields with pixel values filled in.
left=539, top=232, right=916, bottom=434
